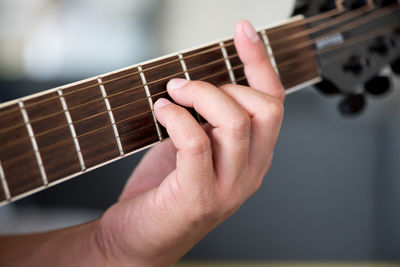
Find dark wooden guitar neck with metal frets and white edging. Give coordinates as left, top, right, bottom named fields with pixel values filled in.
left=0, top=15, right=319, bottom=204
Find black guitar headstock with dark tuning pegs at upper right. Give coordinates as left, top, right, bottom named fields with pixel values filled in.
left=295, top=0, right=400, bottom=115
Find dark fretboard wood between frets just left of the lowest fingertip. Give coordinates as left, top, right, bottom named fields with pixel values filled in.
left=102, top=68, right=159, bottom=153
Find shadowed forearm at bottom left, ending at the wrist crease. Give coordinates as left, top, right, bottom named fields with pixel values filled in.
left=0, top=221, right=105, bottom=267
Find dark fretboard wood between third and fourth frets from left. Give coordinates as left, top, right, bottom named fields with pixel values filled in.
left=63, top=80, right=119, bottom=168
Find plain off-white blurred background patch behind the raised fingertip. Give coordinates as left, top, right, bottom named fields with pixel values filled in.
left=161, top=0, right=295, bottom=53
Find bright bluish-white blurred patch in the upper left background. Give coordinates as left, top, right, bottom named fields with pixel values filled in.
left=0, top=0, right=156, bottom=80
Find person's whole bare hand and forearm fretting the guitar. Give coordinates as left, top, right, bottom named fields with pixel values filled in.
left=0, top=21, right=284, bottom=266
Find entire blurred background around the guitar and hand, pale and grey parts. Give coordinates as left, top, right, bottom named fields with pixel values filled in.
left=0, top=0, right=400, bottom=261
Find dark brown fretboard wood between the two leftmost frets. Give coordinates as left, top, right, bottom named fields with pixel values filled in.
left=0, top=105, right=43, bottom=196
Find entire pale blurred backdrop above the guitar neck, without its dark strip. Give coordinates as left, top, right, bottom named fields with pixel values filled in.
left=0, top=0, right=294, bottom=81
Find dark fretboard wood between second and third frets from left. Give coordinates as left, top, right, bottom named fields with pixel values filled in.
left=25, top=93, right=81, bottom=182
